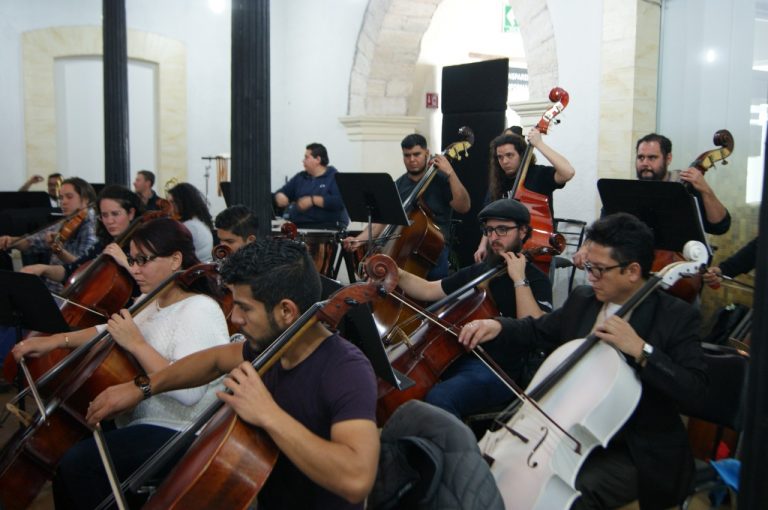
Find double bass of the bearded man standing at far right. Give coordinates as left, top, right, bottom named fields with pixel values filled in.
left=651, top=129, right=734, bottom=303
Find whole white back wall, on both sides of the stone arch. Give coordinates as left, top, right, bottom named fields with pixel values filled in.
left=0, top=0, right=601, bottom=220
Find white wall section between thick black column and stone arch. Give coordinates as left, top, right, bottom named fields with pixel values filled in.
left=270, top=0, right=367, bottom=189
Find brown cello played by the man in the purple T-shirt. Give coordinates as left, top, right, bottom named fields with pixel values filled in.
left=100, top=255, right=397, bottom=510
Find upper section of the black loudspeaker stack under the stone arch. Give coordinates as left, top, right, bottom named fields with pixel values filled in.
left=442, top=58, right=509, bottom=114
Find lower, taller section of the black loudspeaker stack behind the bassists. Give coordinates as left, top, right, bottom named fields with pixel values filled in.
left=442, top=111, right=505, bottom=267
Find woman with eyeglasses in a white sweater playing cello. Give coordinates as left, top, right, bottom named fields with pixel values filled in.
left=13, top=218, right=229, bottom=508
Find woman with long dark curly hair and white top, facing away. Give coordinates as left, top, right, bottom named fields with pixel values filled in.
left=168, top=182, right=213, bottom=262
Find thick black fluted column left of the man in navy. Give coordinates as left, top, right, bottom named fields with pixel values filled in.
left=231, top=0, right=272, bottom=236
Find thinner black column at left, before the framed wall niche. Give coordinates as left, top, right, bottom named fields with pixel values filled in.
left=101, top=0, right=131, bottom=185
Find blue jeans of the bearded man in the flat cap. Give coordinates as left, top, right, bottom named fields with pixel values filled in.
left=424, top=354, right=513, bottom=419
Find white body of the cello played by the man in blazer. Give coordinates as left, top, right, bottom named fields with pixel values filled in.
left=480, top=339, right=641, bottom=510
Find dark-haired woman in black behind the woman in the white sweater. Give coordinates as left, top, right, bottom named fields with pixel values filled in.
left=21, top=185, right=144, bottom=282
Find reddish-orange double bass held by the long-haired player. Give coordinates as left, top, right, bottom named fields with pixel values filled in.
left=508, top=87, right=569, bottom=274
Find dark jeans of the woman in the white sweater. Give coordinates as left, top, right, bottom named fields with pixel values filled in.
left=53, top=425, right=189, bottom=510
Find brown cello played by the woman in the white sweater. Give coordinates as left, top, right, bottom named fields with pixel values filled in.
left=0, top=264, right=222, bottom=509
